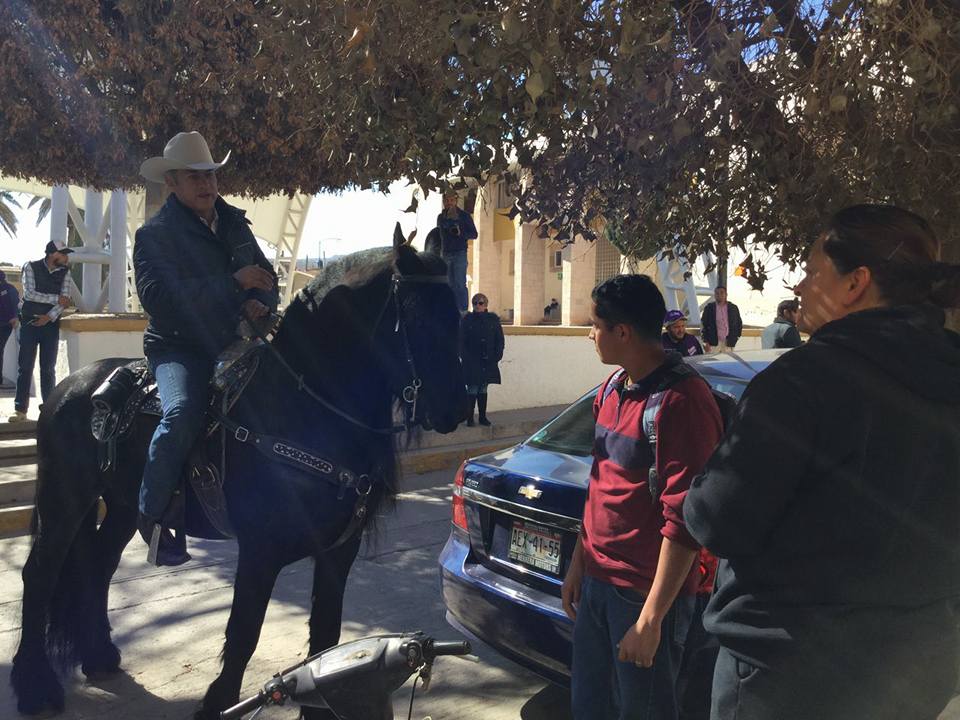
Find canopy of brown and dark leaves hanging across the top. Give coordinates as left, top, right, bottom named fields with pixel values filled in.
left=0, top=0, right=960, bottom=276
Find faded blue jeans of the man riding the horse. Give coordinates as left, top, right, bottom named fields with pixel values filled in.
left=140, top=350, right=213, bottom=520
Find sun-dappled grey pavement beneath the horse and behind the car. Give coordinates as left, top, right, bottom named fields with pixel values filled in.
left=0, top=471, right=568, bottom=720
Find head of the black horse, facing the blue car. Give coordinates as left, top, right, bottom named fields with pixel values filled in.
left=390, top=225, right=467, bottom=433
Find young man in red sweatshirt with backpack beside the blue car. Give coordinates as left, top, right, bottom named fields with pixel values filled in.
left=563, top=275, right=722, bottom=720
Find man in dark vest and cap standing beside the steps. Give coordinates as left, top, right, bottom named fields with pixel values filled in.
left=7, top=240, right=80, bottom=422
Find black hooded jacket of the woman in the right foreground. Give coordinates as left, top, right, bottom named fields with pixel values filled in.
left=684, top=306, right=960, bottom=665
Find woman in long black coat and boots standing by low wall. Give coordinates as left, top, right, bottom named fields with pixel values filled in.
left=460, top=293, right=503, bottom=427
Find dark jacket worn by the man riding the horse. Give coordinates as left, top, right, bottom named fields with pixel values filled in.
left=133, top=195, right=278, bottom=358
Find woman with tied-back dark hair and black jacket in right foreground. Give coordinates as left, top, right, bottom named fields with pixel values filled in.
left=684, top=205, right=960, bottom=720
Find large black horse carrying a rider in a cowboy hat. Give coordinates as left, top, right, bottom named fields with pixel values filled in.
left=11, top=232, right=466, bottom=720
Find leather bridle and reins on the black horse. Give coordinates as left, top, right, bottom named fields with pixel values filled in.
left=248, top=273, right=447, bottom=435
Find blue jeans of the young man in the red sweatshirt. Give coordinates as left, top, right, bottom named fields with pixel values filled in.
left=570, top=575, right=694, bottom=720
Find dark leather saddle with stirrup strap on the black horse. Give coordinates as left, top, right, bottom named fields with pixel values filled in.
left=90, top=339, right=265, bottom=540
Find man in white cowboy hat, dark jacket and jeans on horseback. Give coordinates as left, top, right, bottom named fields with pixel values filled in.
left=133, top=132, right=278, bottom=565
